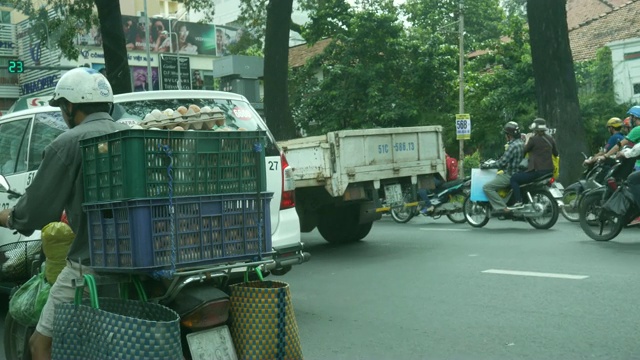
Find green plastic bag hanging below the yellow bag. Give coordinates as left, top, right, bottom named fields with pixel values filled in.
left=9, top=271, right=51, bottom=326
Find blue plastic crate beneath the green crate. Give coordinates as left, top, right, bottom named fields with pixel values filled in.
left=84, top=193, right=273, bottom=272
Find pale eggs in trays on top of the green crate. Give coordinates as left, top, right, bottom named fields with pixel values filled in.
left=139, top=104, right=244, bottom=131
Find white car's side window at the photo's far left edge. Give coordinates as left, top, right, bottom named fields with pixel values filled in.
left=0, top=117, right=31, bottom=176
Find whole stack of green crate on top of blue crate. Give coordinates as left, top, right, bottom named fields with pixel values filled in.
left=81, top=129, right=273, bottom=272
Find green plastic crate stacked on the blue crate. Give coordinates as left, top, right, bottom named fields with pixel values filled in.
left=80, top=129, right=266, bottom=203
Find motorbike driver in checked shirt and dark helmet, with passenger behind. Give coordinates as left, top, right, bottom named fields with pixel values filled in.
left=482, top=121, right=524, bottom=212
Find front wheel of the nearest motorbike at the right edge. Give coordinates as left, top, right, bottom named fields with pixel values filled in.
left=580, top=191, right=624, bottom=241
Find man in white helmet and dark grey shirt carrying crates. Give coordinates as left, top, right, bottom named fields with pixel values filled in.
left=0, top=68, right=129, bottom=360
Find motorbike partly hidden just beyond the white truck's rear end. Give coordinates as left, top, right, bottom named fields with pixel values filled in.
left=390, top=178, right=471, bottom=224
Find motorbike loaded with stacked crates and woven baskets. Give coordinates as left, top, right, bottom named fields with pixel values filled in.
left=0, top=175, right=309, bottom=360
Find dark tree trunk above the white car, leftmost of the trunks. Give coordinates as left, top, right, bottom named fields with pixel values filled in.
left=95, top=0, right=131, bottom=94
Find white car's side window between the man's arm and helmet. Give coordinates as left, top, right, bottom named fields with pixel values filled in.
left=29, top=111, right=67, bottom=171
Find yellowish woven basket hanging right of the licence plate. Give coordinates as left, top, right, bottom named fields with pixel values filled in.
left=229, top=281, right=303, bottom=360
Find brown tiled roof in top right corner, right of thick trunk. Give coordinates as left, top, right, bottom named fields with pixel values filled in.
left=567, top=0, right=640, bottom=61
